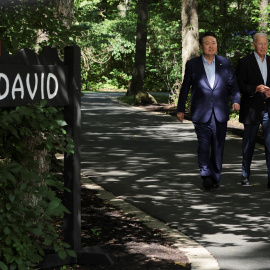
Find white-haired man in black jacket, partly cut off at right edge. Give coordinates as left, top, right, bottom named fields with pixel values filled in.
left=236, top=33, right=270, bottom=188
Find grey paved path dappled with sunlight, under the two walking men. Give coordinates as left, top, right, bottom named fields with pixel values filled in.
left=82, top=93, right=270, bottom=270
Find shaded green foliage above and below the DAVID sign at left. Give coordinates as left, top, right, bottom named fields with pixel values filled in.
left=0, top=0, right=80, bottom=269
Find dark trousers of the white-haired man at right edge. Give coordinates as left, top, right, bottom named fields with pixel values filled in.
left=242, top=112, right=270, bottom=179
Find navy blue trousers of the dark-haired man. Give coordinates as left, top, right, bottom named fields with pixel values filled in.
left=193, top=113, right=227, bottom=183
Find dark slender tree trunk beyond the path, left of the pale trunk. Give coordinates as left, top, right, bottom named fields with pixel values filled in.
left=127, top=0, right=148, bottom=95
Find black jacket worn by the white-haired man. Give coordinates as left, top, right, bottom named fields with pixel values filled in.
left=236, top=53, right=270, bottom=124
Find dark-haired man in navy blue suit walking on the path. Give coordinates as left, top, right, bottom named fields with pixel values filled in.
left=177, top=32, right=240, bottom=189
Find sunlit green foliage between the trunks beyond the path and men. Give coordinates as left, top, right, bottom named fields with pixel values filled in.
left=75, top=0, right=264, bottom=95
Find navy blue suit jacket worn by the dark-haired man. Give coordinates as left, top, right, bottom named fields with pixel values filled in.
left=177, top=55, right=240, bottom=123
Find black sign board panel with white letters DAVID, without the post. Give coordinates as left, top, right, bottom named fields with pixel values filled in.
left=0, top=65, right=68, bottom=107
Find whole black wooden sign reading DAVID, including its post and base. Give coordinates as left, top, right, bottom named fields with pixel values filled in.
left=0, top=46, right=113, bottom=269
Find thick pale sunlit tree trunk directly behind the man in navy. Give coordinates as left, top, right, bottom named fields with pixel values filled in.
left=181, top=0, right=200, bottom=78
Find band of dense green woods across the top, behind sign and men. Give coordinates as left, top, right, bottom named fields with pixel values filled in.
left=0, top=0, right=269, bottom=95
